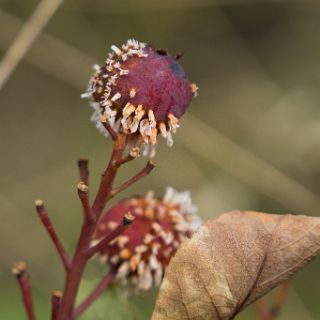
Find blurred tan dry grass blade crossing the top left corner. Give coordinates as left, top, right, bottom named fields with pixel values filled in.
left=0, top=0, right=63, bottom=90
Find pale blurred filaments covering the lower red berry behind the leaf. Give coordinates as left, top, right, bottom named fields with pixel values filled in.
left=94, top=188, right=201, bottom=290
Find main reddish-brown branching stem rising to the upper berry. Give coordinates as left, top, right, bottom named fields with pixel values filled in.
left=58, top=133, right=145, bottom=320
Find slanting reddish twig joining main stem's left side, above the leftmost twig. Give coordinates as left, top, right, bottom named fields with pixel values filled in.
left=35, top=200, right=71, bottom=271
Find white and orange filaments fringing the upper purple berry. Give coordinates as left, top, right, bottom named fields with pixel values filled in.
left=81, top=39, right=198, bottom=157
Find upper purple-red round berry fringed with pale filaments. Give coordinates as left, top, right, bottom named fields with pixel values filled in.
left=83, top=40, right=197, bottom=156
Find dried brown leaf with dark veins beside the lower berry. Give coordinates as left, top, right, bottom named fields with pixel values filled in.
left=152, top=211, right=320, bottom=320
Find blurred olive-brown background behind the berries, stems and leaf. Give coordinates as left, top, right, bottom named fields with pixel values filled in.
left=0, top=0, right=320, bottom=320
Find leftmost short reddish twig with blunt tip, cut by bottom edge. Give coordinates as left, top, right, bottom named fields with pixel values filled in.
left=11, top=262, right=36, bottom=320
